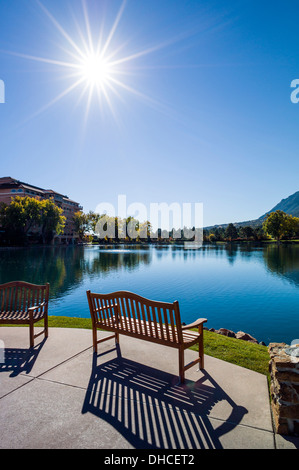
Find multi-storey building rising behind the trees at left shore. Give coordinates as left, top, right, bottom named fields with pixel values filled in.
left=0, top=176, right=82, bottom=244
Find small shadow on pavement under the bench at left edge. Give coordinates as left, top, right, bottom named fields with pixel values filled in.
left=0, top=339, right=46, bottom=377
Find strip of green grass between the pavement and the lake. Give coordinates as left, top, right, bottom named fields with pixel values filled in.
left=33, top=316, right=270, bottom=380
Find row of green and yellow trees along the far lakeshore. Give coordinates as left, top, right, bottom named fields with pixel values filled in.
left=0, top=196, right=299, bottom=246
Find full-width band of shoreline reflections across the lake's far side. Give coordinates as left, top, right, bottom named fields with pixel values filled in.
left=0, top=244, right=299, bottom=296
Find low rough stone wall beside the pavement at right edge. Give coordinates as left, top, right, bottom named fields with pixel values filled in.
left=268, top=343, right=299, bottom=436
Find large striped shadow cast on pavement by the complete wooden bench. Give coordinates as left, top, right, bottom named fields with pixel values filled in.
left=82, top=346, right=248, bottom=449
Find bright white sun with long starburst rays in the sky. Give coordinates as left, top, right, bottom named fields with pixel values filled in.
left=8, top=0, right=174, bottom=120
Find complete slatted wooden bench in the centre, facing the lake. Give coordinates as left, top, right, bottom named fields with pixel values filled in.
left=87, top=291, right=207, bottom=383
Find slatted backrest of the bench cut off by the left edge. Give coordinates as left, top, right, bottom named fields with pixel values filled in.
left=0, top=281, right=49, bottom=312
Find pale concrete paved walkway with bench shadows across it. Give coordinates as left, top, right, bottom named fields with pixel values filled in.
left=0, top=327, right=299, bottom=450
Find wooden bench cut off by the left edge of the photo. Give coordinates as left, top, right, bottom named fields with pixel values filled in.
left=0, top=281, right=50, bottom=348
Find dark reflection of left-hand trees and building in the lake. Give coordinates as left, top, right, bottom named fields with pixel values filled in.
left=0, top=247, right=151, bottom=298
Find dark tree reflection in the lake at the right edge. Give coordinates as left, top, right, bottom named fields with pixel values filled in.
left=263, top=244, right=299, bottom=286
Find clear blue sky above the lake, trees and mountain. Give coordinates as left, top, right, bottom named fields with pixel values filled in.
left=0, top=0, right=299, bottom=226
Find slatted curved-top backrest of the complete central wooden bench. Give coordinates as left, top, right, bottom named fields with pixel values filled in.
left=87, top=291, right=182, bottom=344
